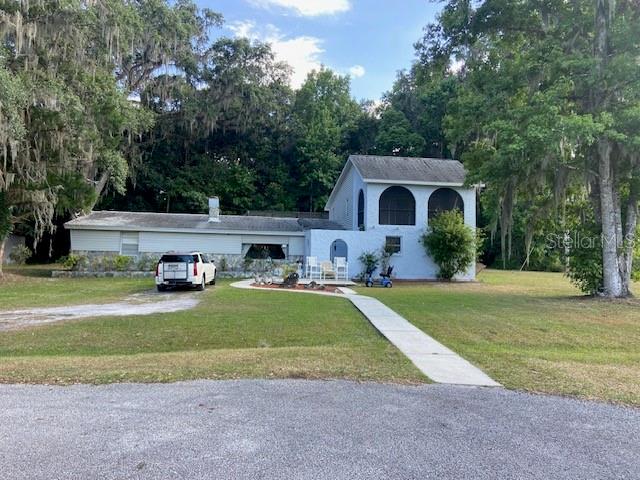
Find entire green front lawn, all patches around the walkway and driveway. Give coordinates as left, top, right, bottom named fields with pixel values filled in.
left=0, top=269, right=640, bottom=405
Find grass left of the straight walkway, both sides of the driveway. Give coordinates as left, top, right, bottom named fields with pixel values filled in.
left=0, top=277, right=428, bottom=384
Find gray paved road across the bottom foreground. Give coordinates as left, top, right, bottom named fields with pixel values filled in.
left=0, top=380, right=640, bottom=480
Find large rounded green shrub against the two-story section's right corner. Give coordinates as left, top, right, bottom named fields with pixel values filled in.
left=421, top=210, right=476, bottom=280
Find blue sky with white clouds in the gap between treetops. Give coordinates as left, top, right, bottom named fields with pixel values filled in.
left=196, top=0, right=440, bottom=100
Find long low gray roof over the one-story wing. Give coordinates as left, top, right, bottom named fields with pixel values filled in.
left=65, top=210, right=344, bottom=233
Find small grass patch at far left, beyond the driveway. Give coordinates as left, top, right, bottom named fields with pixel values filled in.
left=0, top=266, right=153, bottom=310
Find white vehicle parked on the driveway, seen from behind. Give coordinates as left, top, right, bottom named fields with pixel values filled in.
left=156, top=252, right=216, bottom=292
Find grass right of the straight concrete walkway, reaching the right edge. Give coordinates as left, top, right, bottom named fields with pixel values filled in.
left=360, top=270, right=640, bottom=405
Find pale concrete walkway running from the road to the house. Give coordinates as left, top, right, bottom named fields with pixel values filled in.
left=231, top=280, right=501, bottom=387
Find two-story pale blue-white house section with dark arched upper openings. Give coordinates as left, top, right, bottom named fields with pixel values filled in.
left=305, top=155, right=476, bottom=280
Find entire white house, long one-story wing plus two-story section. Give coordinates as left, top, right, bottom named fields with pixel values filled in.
left=65, top=155, right=476, bottom=279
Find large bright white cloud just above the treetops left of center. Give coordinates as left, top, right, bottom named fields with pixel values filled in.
left=229, top=20, right=324, bottom=88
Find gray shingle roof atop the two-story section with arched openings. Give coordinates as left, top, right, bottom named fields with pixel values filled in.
left=349, top=155, right=465, bottom=184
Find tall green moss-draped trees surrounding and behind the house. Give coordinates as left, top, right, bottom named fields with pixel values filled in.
left=0, top=0, right=640, bottom=296
